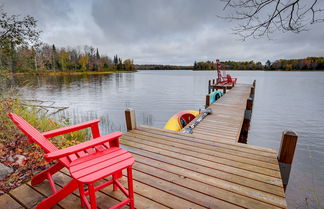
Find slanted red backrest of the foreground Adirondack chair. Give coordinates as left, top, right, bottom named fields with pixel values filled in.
left=9, top=113, right=58, bottom=153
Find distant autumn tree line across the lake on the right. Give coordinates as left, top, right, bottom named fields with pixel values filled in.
left=193, top=57, right=324, bottom=71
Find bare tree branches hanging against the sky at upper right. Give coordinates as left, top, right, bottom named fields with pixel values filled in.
left=221, top=0, right=324, bottom=39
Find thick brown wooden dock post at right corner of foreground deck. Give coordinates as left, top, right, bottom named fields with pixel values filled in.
left=278, top=131, right=298, bottom=191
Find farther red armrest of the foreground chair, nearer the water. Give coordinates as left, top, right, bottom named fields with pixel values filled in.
left=42, top=120, right=100, bottom=138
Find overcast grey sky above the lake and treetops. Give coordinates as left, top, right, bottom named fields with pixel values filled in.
left=0, top=0, right=324, bottom=65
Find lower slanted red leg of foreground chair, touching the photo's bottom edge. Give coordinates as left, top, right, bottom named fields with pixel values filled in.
left=36, top=179, right=78, bottom=209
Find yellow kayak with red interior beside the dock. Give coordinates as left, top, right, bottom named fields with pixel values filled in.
left=164, top=110, right=199, bottom=131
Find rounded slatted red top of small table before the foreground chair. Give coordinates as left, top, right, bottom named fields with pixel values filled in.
left=69, top=147, right=134, bottom=184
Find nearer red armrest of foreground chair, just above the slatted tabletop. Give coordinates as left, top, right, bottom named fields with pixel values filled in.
left=44, top=132, right=123, bottom=160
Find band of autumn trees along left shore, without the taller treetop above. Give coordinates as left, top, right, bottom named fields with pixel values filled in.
left=0, top=43, right=134, bottom=73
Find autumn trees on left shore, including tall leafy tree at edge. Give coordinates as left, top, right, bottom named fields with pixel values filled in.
left=0, top=7, right=134, bottom=73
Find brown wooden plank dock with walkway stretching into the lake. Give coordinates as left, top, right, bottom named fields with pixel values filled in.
left=0, top=82, right=287, bottom=209
